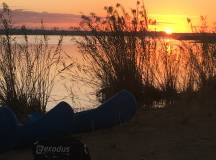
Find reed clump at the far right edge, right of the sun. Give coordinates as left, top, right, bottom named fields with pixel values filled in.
left=182, top=16, right=216, bottom=97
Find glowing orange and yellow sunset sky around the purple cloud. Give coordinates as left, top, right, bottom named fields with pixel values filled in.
left=1, top=0, right=216, bottom=32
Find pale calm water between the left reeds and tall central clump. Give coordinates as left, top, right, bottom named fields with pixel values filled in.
left=16, top=36, right=98, bottom=111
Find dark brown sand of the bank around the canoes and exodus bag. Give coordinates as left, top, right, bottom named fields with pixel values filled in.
left=0, top=104, right=216, bottom=160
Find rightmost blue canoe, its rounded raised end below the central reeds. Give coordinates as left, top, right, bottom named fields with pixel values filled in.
left=71, top=90, right=136, bottom=133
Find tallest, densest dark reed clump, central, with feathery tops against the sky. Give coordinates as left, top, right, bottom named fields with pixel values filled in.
left=77, top=1, right=160, bottom=104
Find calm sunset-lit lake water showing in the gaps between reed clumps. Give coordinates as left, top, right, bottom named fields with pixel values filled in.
left=16, top=36, right=213, bottom=111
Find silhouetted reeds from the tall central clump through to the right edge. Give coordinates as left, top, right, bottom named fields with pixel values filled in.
left=77, top=1, right=216, bottom=106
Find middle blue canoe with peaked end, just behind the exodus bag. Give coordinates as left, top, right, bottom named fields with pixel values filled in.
left=16, top=102, right=74, bottom=146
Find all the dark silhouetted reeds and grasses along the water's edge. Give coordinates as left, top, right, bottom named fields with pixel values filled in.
left=0, top=1, right=216, bottom=118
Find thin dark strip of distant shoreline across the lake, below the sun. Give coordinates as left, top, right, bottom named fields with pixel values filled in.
left=0, top=29, right=216, bottom=42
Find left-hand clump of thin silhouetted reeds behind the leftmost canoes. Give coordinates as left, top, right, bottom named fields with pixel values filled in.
left=0, top=4, right=62, bottom=120
